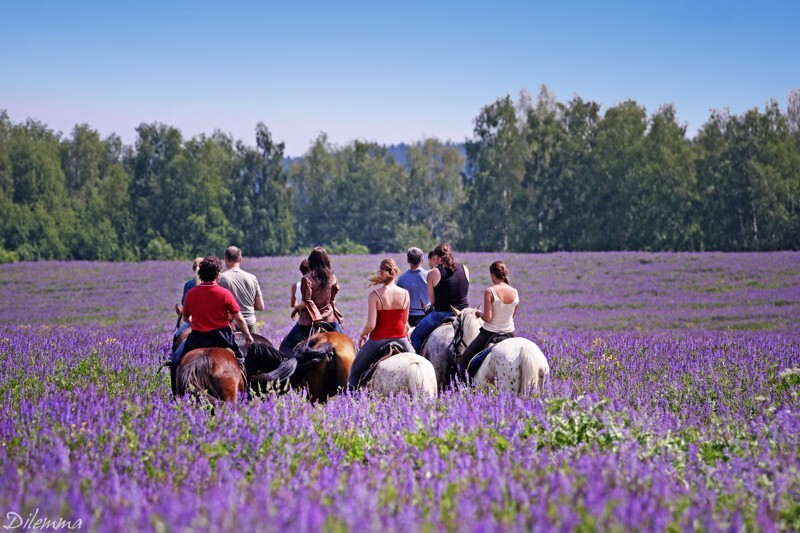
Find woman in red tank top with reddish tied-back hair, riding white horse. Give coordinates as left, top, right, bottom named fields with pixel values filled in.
left=347, top=259, right=414, bottom=388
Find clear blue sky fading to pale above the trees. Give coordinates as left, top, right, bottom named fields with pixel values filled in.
left=0, top=0, right=800, bottom=156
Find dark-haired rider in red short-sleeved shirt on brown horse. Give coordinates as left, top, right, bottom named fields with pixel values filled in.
left=172, top=255, right=253, bottom=371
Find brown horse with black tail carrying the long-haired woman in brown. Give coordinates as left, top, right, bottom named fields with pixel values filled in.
left=292, top=331, right=356, bottom=402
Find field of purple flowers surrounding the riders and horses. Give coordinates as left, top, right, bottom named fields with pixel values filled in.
left=0, top=252, right=800, bottom=532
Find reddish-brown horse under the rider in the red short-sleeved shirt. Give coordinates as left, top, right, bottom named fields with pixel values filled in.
left=175, top=348, right=245, bottom=402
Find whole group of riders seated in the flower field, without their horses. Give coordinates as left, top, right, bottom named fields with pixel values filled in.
left=170, top=243, right=519, bottom=388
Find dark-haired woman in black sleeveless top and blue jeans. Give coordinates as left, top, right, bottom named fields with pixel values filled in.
left=411, top=243, right=469, bottom=353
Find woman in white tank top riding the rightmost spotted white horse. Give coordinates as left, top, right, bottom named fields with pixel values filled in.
left=457, top=261, right=519, bottom=382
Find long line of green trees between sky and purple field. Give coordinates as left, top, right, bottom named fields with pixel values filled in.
left=0, top=87, right=800, bottom=261
